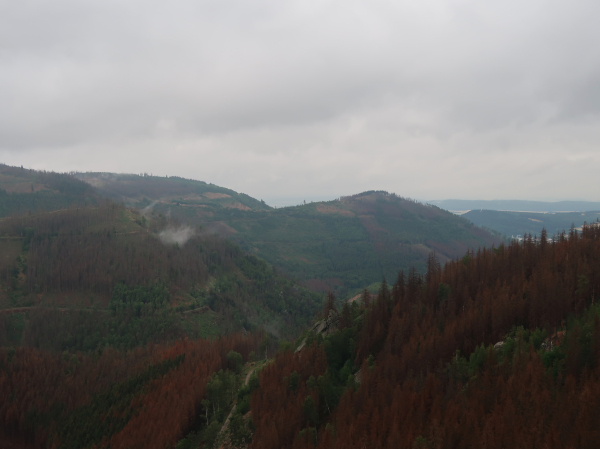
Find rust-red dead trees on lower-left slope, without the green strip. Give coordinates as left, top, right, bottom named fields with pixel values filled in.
left=0, top=334, right=259, bottom=449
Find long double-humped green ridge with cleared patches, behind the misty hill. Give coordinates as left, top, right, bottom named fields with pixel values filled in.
left=72, top=173, right=500, bottom=296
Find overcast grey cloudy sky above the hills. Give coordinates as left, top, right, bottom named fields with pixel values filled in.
left=0, top=0, right=600, bottom=205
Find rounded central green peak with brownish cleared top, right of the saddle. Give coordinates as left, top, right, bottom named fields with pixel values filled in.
left=228, top=192, right=501, bottom=297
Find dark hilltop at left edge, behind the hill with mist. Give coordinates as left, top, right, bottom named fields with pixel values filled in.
left=0, top=164, right=96, bottom=218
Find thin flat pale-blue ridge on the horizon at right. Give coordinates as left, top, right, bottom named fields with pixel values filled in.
left=427, top=200, right=600, bottom=212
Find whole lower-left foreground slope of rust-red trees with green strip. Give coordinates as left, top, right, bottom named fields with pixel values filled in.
left=0, top=328, right=260, bottom=449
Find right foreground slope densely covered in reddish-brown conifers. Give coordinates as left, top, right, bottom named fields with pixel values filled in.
left=251, top=222, right=600, bottom=449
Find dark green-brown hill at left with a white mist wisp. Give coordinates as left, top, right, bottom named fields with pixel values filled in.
left=0, top=201, right=321, bottom=350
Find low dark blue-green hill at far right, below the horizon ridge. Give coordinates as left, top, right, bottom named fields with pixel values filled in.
left=462, top=210, right=600, bottom=237
